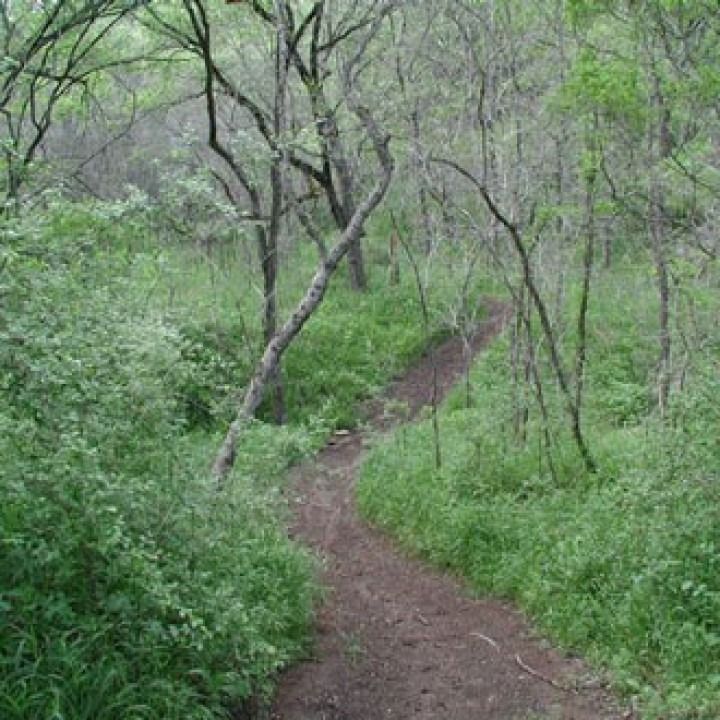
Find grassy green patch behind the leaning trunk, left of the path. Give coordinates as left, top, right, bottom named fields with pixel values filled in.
left=135, top=231, right=438, bottom=438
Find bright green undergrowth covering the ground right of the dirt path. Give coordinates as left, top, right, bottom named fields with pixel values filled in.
left=358, top=260, right=720, bottom=720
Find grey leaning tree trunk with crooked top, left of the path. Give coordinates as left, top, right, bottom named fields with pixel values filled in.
left=212, top=103, right=393, bottom=485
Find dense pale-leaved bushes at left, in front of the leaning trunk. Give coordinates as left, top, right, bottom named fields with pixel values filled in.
left=0, top=209, right=314, bottom=720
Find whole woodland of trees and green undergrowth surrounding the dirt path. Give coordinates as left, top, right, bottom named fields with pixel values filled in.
left=0, top=0, right=720, bottom=720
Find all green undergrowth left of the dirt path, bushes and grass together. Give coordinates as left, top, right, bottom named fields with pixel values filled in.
left=0, top=203, right=448, bottom=720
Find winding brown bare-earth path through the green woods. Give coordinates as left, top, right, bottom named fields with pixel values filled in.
left=272, top=302, right=631, bottom=720
